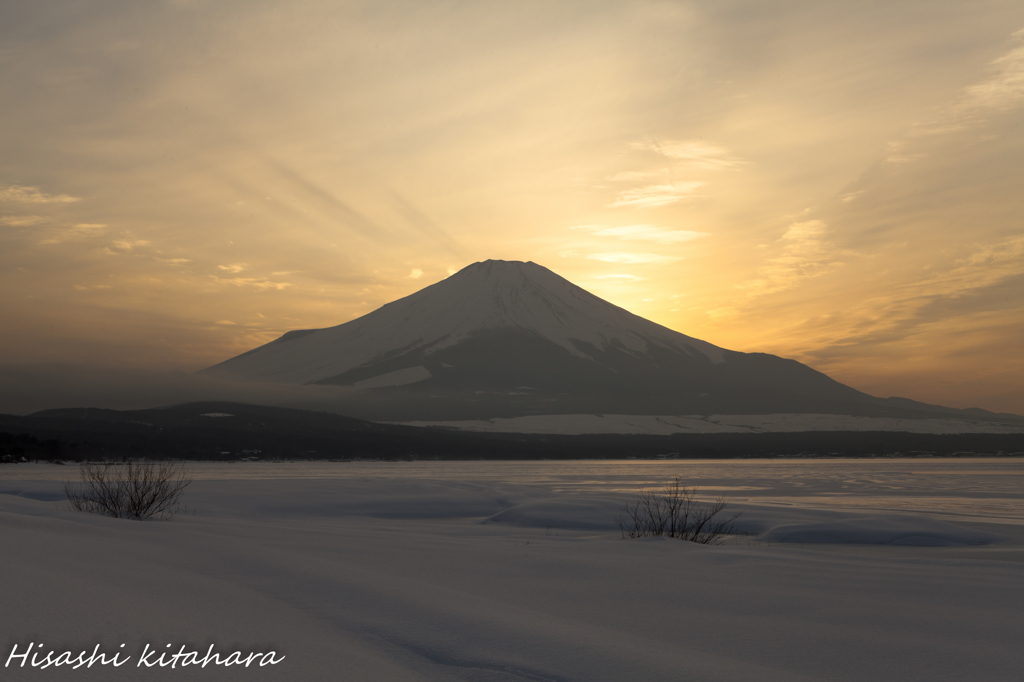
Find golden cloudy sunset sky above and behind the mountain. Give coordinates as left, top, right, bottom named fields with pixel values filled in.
left=0, top=0, right=1024, bottom=414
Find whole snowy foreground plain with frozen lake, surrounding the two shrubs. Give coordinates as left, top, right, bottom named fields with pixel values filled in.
left=0, top=459, right=1024, bottom=682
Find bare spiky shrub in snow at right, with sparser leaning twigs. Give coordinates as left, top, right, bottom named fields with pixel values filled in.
left=618, top=476, right=743, bottom=545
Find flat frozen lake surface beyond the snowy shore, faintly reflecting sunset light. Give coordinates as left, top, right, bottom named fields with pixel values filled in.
left=6, top=458, right=1024, bottom=523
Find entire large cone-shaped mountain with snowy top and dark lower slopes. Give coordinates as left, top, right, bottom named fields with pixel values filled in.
left=204, top=260, right=1015, bottom=420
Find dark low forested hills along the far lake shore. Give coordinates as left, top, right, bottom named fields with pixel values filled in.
left=0, top=402, right=1024, bottom=460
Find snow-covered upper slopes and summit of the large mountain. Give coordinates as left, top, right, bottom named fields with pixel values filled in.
left=207, top=260, right=723, bottom=383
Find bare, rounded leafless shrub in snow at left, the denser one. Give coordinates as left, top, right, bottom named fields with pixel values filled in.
left=63, top=461, right=193, bottom=519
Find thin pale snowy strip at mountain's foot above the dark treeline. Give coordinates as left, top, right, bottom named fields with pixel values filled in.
left=396, top=414, right=1024, bottom=435
